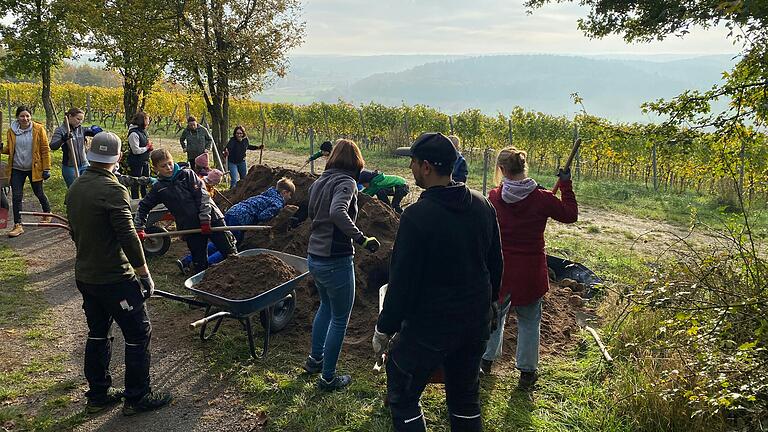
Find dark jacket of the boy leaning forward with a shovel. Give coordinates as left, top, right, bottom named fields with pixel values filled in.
left=134, top=165, right=224, bottom=230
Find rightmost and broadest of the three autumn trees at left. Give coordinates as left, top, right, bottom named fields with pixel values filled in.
left=173, top=0, right=304, bottom=144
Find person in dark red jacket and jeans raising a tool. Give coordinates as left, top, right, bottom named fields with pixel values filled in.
left=480, top=147, right=579, bottom=391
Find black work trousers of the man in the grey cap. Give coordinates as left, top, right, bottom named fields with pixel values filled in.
left=76, top=277, right=152, bottom=402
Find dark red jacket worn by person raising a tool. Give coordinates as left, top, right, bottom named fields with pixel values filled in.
left=488, top=180, right=579, bottom=306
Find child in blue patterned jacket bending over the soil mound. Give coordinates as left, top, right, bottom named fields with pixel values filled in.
left=176, top=177, right=296, bottom=274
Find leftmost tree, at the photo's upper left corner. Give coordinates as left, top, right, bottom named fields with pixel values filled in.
left=0, top=0, right=82, bottom=129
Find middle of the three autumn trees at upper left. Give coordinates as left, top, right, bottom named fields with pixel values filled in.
left=88, top=0, right=178, bottom=123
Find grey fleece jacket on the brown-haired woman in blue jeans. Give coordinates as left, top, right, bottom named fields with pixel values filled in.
left=307, top=169, right=365, bottom=257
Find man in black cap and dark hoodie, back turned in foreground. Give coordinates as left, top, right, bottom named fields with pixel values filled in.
left=373, top=133, right=503, bottom=431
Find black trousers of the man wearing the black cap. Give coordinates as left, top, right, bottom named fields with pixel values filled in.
left=387, top=329, right=486, bottom=432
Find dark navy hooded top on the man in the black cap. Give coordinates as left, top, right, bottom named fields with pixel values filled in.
left=377, top=183, right=503, bottom=346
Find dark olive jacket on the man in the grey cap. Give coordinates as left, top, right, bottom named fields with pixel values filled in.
left=65, top=166, right=145, bottom=285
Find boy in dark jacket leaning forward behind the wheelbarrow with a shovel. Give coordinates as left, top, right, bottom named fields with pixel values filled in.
left=134, top=149, right=237, bottom=272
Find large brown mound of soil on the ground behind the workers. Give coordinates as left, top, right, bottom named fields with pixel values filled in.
left=213, top=165, right=580, bottom=364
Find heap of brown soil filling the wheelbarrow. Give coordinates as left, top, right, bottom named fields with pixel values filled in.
left=201, top=254, right=298, bottom=300
